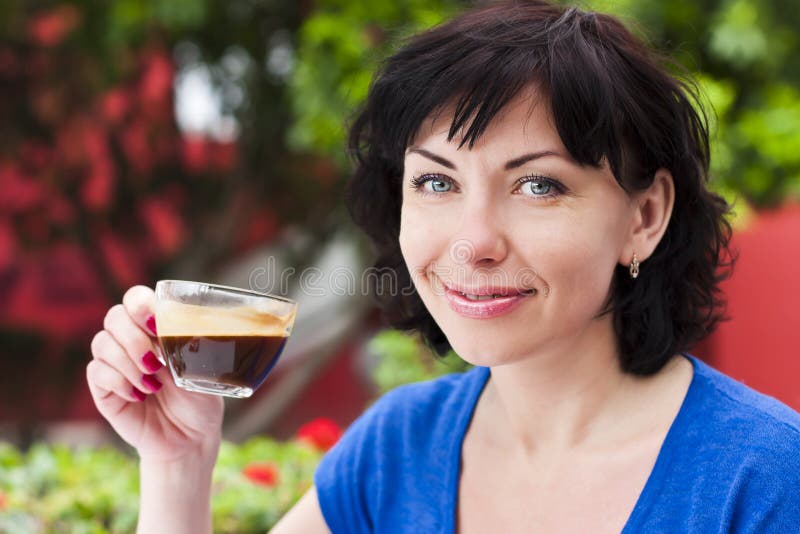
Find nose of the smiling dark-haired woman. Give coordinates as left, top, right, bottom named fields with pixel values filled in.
left=449, top=202, right=508, bottom=267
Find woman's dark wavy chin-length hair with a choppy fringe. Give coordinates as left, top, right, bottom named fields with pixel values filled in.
left=346, top=1, right=734, bottom=375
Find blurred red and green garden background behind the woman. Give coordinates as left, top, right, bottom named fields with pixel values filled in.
left=0, top=0, right=800, bottom=532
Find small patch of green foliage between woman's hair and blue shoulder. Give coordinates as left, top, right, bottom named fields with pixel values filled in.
left=368, top=330, right=470, bottom=393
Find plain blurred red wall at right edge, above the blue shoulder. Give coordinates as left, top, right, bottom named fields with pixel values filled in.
left=704, top=204, right=800, bottom=411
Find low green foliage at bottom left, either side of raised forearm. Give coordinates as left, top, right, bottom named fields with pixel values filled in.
left=0, top=437, right=321, bottom=534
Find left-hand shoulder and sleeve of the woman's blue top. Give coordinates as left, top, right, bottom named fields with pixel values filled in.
left=314, top=367, right=489, bottom=533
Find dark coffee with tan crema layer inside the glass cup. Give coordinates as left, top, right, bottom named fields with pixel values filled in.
left=156, top=301, right=294, bottom=397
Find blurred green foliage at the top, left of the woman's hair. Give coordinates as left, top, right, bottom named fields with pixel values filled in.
left=288, top=0, right=458, bottom=164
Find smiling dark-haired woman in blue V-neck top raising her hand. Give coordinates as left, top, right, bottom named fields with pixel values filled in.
left=87, top=1, right=800, bottom=533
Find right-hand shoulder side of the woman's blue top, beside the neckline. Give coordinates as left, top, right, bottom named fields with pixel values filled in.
left=633, top=355, right=800, bottom=533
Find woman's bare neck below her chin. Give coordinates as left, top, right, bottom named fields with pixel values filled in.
left=482, top=318, right=648, bottom=456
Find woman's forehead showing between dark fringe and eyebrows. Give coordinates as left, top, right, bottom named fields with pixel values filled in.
left=411, top=88, right=566, bottom=157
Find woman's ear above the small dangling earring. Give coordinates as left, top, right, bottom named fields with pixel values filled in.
left=620, top=168, right=675, bottom=265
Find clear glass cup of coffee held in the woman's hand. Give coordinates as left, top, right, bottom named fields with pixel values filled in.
left=155, top=280, right=297, bottom=398
